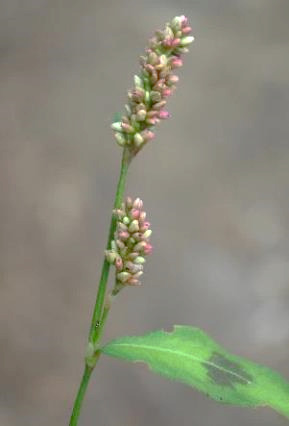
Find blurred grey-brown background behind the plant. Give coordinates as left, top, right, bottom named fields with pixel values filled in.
left=0, top=0, right=289, bottom=426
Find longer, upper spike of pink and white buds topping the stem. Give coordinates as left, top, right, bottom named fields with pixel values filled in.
left=111, top=16, right=194, bottom=154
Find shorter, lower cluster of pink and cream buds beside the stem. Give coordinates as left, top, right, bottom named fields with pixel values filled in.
left=105, top=197, right=152, bottom=289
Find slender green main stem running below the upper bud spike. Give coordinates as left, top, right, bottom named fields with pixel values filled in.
left=69, top=148, right=132, bottom=426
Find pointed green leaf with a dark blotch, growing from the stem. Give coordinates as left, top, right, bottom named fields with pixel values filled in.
left=101, top=325, right=289, bottom=418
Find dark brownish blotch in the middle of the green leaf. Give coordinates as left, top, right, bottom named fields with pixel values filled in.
left=202, top=352, right=253, bottom=388
